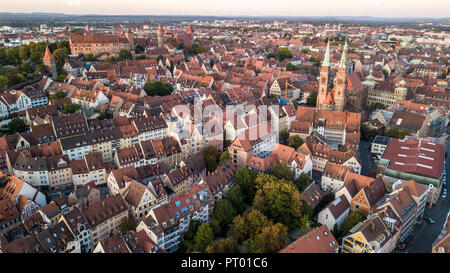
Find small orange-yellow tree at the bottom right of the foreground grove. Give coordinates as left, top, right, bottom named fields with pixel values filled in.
left=254, top=223, right=288, bottom=253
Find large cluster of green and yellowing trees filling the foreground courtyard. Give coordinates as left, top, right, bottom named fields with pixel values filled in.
left=178, top=160, right=315, bottom=253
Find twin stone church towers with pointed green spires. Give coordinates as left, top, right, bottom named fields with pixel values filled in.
left=316, top=40, right=348, bottom=111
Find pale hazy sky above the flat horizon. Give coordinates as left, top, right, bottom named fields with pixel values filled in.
left=0, top=0, right=450, bottom=18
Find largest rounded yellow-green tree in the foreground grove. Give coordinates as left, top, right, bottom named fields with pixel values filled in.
left=253, top=177, right=303, bottom=229
